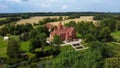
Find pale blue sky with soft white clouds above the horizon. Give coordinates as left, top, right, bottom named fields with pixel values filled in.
left=0, top=0, right=120, bottom=13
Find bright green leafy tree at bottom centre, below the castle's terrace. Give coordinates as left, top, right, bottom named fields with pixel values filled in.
left=46, top=51, right=81, bottom=68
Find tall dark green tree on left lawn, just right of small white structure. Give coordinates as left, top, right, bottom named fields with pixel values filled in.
left=7, top=38, right=20, bottom=58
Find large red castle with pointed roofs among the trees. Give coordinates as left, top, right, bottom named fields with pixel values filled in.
left=46, top=23, right=76, bottom=42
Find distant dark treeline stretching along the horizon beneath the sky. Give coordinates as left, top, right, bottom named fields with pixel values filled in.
left=0, top=12, right=120, bottom=17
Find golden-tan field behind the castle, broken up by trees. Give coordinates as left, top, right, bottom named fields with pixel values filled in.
left=17, top=16, right=97, bottom=25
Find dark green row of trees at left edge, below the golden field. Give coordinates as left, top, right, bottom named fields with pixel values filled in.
left=0, top=24, right=33, bottom=36
